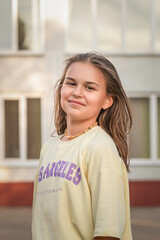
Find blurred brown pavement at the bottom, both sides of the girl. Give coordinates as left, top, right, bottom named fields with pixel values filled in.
left=0, top=207, right=160, bottom=240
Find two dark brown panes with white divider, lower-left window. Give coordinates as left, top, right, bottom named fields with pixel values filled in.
left=0, top=97, right=42, bottom=160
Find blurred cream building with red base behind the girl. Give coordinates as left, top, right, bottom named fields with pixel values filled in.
left=0, top=0, right=160, bottom=206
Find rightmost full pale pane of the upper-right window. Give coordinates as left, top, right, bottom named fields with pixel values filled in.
left=126, top=0, right=150, bottom=52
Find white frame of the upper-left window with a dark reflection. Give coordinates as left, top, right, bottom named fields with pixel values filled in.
left=0, top=0, right=45, bottom=56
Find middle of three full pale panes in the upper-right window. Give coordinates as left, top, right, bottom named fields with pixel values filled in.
left=97, top=0, right=121, bottom=51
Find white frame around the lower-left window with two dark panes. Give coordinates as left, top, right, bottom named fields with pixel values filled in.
left=0, top=93, right=46, bottom=167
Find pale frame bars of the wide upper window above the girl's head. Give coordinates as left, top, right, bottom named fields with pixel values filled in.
left=65, top=0, right=160, bottom=56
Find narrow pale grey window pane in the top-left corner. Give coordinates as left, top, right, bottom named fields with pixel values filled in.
left=0, top=0, right=12, bottom=50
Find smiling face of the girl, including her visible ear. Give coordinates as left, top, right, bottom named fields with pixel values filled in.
left=61, top=62, right=113, bottom=124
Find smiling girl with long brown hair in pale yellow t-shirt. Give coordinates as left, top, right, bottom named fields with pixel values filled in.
left=33, top=53, right=132, bottom=240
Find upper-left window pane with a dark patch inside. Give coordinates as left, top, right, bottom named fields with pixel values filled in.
left=18, top=0, right=41, bottom=50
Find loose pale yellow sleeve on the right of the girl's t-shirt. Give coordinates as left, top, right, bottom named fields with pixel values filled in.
left=88, top=143, right=132, bottom=240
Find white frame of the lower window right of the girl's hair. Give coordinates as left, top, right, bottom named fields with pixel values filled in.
left=128, top=92, right=160, bottom=167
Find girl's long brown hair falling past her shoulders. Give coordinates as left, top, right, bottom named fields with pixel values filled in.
left=55, top=52, right=132, bottom=170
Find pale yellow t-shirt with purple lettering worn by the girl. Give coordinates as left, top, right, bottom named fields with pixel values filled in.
left=32, top=126, right=132, bottom=240
